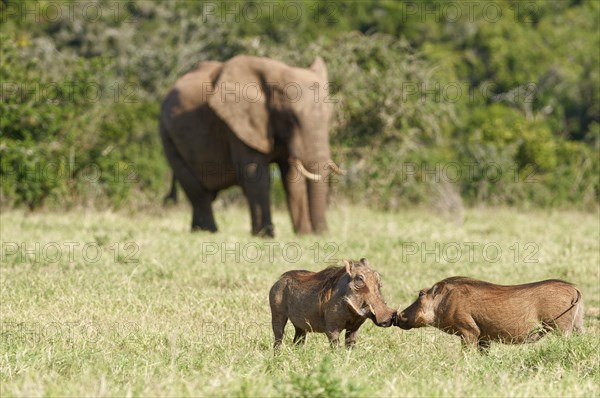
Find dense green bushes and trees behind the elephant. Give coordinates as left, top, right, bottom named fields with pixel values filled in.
left=0, top=0, right=600, bottom=209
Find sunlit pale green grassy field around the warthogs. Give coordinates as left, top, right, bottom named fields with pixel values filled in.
left=0, top=206, right=600, bottom=397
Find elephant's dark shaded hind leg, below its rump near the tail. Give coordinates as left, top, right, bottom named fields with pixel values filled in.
left=161, top=132, right=217, bottom=232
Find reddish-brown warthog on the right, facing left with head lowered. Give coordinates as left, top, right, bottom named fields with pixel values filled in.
left=394, top=276, right=583, bottom=351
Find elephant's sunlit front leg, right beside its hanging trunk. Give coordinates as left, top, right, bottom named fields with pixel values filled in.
left=278, top=159, right=312, bottom=234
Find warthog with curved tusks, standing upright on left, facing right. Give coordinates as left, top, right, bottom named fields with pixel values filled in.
left=269, top=258, right=396, bottom=348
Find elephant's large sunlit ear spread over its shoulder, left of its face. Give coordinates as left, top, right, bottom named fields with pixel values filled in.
left=208, top=56, right=273, bottom=153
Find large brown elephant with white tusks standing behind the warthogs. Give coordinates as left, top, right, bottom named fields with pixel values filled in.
left=159, top=55, right=344, bottom=237
